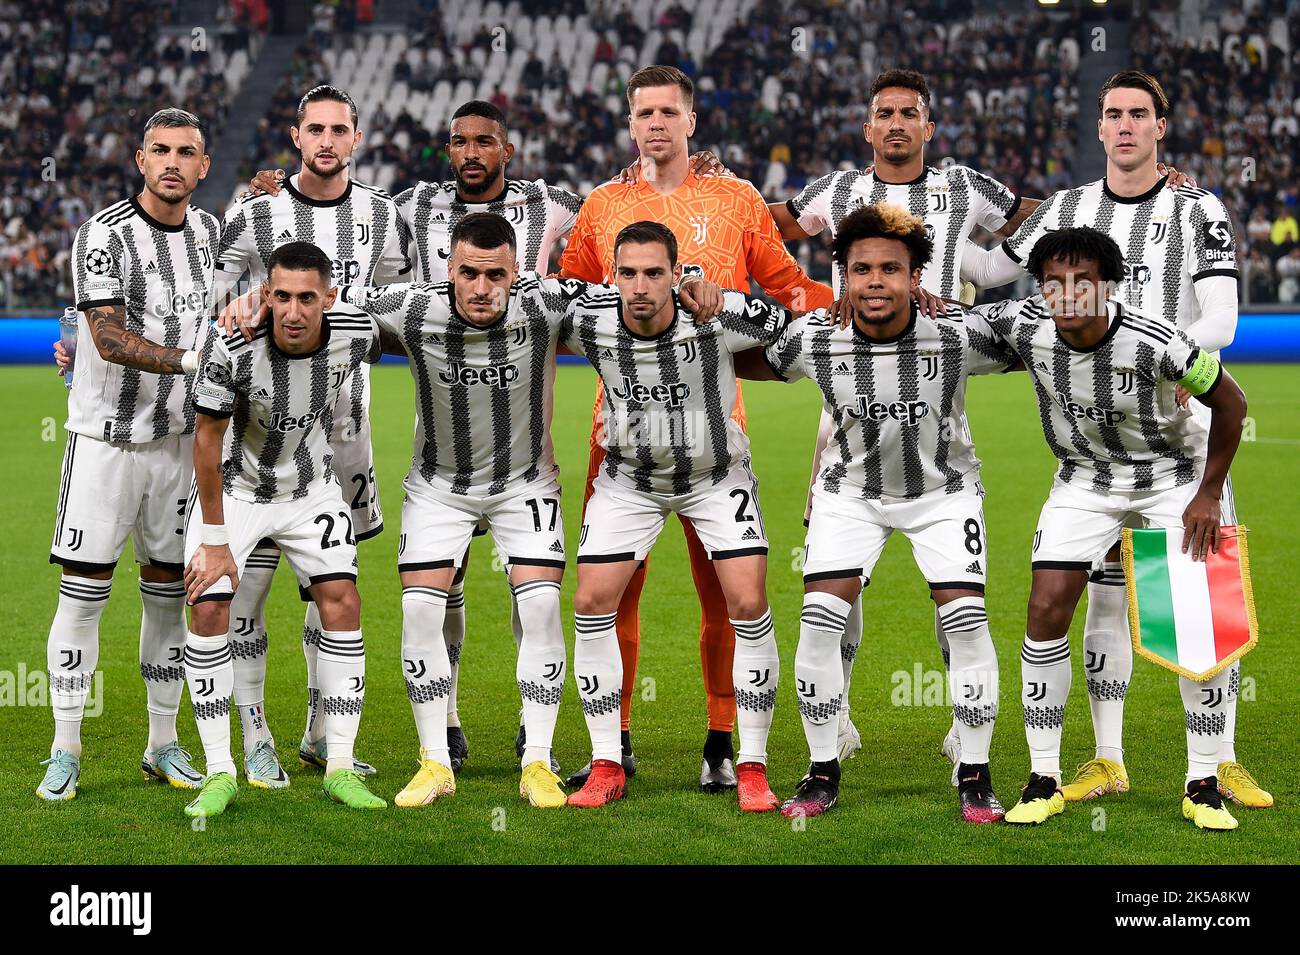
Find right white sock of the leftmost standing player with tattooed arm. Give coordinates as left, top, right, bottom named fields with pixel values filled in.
left=140, top=579, right=186, bottom=750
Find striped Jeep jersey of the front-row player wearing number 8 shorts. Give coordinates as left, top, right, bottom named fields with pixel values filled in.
left=763, top=305, right=1015, bottom=502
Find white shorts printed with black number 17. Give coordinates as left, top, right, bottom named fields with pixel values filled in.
left=398, top=472, right=564, bottom=573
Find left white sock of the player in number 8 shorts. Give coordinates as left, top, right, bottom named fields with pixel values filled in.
left=794, top=592, right=850, bottom=763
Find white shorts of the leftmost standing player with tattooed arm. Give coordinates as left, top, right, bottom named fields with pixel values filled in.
left=49, top=431, right=194, bottom=573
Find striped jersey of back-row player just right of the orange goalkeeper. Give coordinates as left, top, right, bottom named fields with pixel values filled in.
left=787, top=165, right=1021, bottom=299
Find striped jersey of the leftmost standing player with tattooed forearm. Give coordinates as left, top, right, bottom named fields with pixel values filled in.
left=65, top=196, right=221, bottom=444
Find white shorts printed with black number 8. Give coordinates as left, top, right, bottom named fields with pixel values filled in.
left=803, top=487, right=988, bottom=592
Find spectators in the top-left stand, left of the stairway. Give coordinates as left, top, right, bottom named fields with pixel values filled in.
left=0, top=0, right=255, bottom=308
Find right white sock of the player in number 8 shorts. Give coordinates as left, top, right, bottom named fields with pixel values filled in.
left=937, top=596, right=997, bottom=765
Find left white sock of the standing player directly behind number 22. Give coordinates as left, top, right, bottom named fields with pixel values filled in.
left=230, top=547, right=280, bottom=756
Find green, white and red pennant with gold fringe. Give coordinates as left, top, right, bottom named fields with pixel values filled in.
left=1123, top=525, right=1258, bottom=681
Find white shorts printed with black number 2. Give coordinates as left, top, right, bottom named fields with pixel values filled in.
left=577, top=457, right=767, bottom=564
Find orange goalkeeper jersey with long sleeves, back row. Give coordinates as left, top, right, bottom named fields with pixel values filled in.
left=560, top=173, right=832, bottom=312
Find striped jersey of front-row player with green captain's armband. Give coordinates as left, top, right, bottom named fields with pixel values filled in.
left=974, top=296, right=1205, bottom=494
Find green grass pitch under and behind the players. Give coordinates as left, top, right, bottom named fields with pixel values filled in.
left=0, top=365, right=1300, bottom=864
